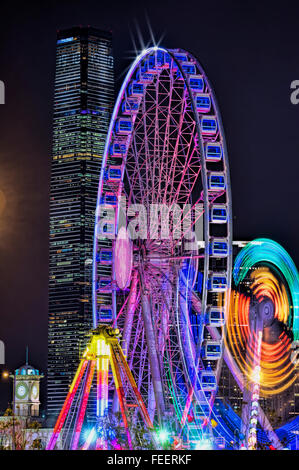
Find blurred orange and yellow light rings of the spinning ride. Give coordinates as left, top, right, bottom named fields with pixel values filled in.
left=225, top=267, right=296, bottom=396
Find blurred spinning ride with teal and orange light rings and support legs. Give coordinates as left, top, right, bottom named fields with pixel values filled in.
left=226, top=238, right=299, bottom=449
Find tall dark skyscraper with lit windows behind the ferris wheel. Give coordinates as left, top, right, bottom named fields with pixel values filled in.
left=47, top=27, right=114, bottom=418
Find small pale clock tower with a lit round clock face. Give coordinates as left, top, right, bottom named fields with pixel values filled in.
left=13, top=359, right=44, bottom=417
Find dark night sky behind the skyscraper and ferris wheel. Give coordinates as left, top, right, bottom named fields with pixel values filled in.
left=0, top=0, right=299, bottom=410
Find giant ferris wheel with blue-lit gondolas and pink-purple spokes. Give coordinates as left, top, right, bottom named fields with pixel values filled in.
left=93, top=47, right=232, bottom=439
